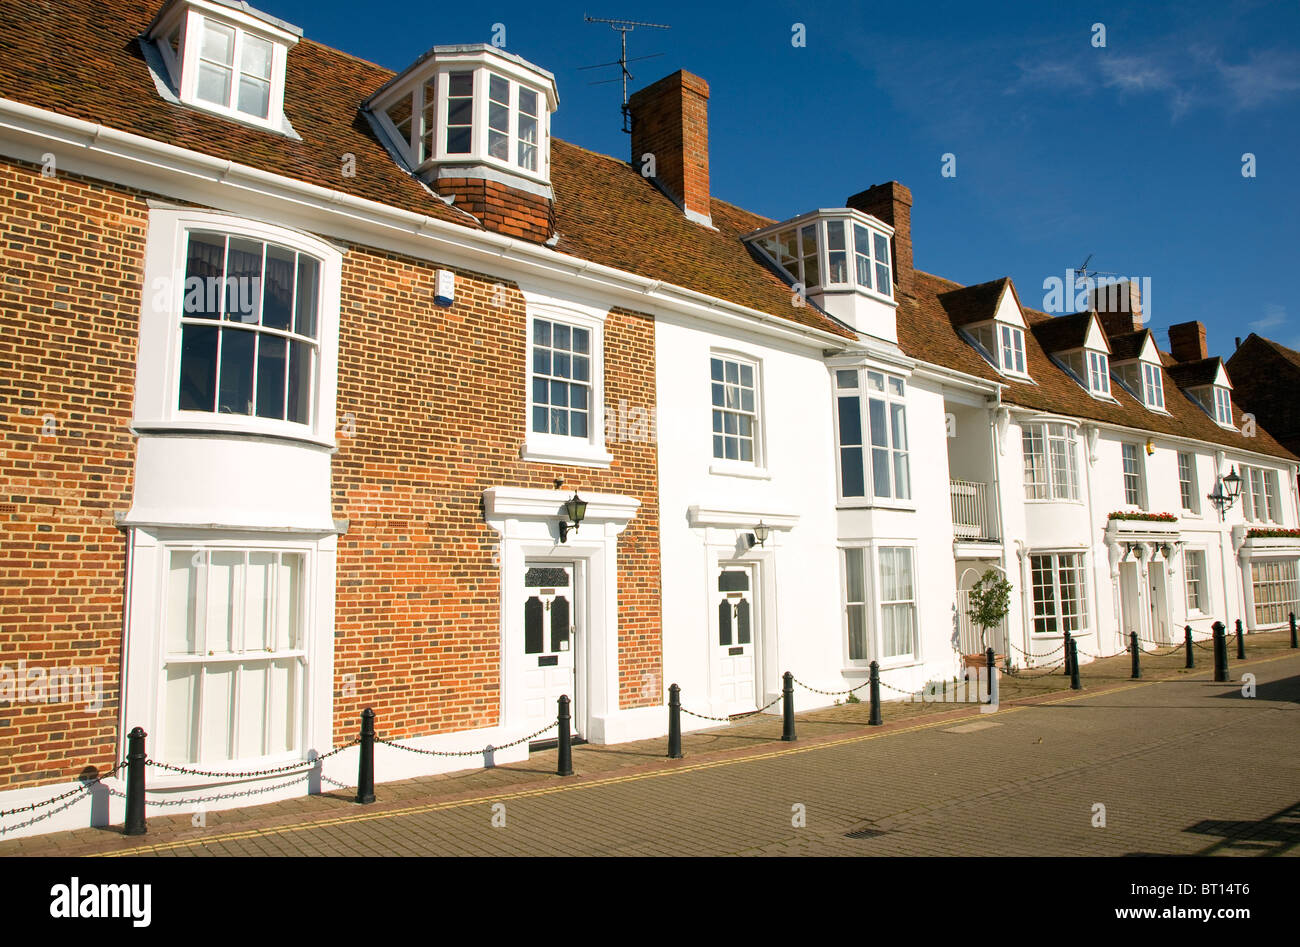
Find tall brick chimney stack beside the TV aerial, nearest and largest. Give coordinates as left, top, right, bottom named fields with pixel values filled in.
left=628, top=70, right=712, bottom=226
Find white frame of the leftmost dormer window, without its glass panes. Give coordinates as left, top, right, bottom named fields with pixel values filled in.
left=151, top=6, right=298, bottom=134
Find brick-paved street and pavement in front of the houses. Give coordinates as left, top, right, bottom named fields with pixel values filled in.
left=0, top=635, right=1300, bottom=856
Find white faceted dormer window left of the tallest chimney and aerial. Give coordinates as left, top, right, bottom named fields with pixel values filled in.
left=368, top=44, right=558, bottom=187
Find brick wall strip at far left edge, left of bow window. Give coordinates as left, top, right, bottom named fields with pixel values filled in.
left=0, top=161, right=147, bottom=788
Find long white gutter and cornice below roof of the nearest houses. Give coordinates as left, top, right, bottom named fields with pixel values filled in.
left=0, top=98, right=853, bottom=350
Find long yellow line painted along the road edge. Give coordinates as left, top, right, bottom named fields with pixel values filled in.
left=98, top=654, right=1296, bottom=859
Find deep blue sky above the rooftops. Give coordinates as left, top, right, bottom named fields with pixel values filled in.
left=276, top=0, right=1300, bottom=356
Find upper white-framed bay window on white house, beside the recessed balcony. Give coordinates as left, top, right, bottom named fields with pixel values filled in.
left=835, top=368, right=911, bottom=500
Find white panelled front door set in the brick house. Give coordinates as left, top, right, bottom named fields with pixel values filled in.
left=521, top=561, right=581, bottom=739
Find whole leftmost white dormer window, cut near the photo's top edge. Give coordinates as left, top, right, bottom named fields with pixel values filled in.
left=148, top=0, right=302, bottom=131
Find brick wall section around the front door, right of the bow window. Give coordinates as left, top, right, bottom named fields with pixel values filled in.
left=334, top=247, right=662, bottom=736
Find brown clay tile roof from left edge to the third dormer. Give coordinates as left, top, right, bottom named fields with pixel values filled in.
left=0, top=0, right=854, bottom=338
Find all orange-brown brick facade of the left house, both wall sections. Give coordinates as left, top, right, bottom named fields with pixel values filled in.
left=0, top=153, right=662, bottom=790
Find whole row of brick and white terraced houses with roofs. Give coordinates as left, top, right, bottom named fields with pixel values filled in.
left=0, top=0, right=1300, bottom=833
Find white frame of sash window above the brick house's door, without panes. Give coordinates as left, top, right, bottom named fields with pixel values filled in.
left=520, top=297, right=614, bottom=467
